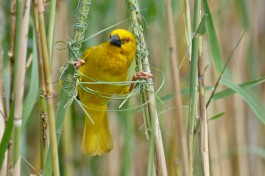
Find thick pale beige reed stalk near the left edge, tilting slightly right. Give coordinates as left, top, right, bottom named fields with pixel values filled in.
left=14, top=0, right=30, bottom=175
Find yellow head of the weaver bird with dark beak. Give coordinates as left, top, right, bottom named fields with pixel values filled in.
left=109, top=29, right=136, bottom=56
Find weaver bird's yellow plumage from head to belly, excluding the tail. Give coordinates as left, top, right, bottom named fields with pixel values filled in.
left=78, top=29, right=136, bottom=105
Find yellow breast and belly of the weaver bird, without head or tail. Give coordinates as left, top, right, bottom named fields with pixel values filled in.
left=79, top=43, right=130, bottom=104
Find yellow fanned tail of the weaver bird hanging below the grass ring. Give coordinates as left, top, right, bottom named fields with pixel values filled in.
left=81, top=105, right=113, bottom=156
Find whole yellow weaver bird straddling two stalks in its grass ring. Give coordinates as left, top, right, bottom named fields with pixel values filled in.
left=73, top=29, right=152, bottom=156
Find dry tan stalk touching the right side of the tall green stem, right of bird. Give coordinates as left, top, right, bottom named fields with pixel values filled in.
left=198, top=30, right=210, bottom=176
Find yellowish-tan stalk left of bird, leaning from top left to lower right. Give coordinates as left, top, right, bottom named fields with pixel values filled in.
left=38, top=0, right=60, bottom=176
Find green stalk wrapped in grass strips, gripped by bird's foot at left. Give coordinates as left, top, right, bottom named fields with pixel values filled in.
left=41, top=0, right=91, bottom=176
